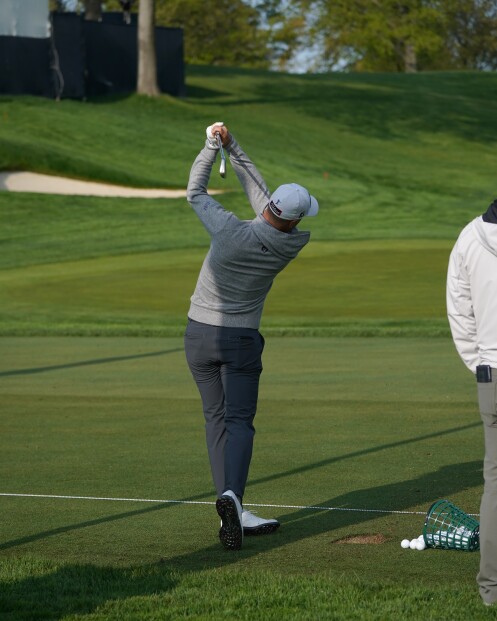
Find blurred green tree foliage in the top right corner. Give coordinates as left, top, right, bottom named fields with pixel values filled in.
left=297, top=0, right=497, bottom=71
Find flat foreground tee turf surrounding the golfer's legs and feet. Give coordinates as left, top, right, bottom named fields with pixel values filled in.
left=0, top=337, right=491, bottom=619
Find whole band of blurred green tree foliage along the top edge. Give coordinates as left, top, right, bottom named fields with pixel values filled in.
left=50, top=0, right=497, bottom=72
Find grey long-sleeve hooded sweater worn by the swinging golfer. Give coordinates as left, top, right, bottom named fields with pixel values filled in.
left=187, top=139, right=310, bottom=329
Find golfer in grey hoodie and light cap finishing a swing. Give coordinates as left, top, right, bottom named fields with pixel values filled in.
left=185, top=123, right=319, bottom=550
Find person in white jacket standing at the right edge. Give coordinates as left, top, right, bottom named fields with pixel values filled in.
left=447, top=200, right=497, bottom=606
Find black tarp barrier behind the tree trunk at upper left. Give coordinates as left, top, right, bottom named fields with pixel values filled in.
left=0, top=13, right=185, bottom=99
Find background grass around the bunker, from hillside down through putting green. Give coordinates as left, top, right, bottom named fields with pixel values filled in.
left=0, top=68, right=497, bottom=334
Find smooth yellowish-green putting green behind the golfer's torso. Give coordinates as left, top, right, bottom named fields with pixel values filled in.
left=0, top=241, right=450, bottom=335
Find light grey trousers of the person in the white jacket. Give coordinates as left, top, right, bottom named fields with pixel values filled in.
left=477, top=369, right=497, bottom=604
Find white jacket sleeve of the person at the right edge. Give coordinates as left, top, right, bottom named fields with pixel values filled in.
left=447, top=243, right=479, bottom=373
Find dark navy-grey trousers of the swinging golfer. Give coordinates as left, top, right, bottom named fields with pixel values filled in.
left=185, top=319, right=264, bottom=498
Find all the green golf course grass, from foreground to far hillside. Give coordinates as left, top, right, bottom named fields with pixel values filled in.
left=0, top=68, right=497, bottom=621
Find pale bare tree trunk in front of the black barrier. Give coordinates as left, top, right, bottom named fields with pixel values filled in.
left=138, top=0, right=160, bottom=97
